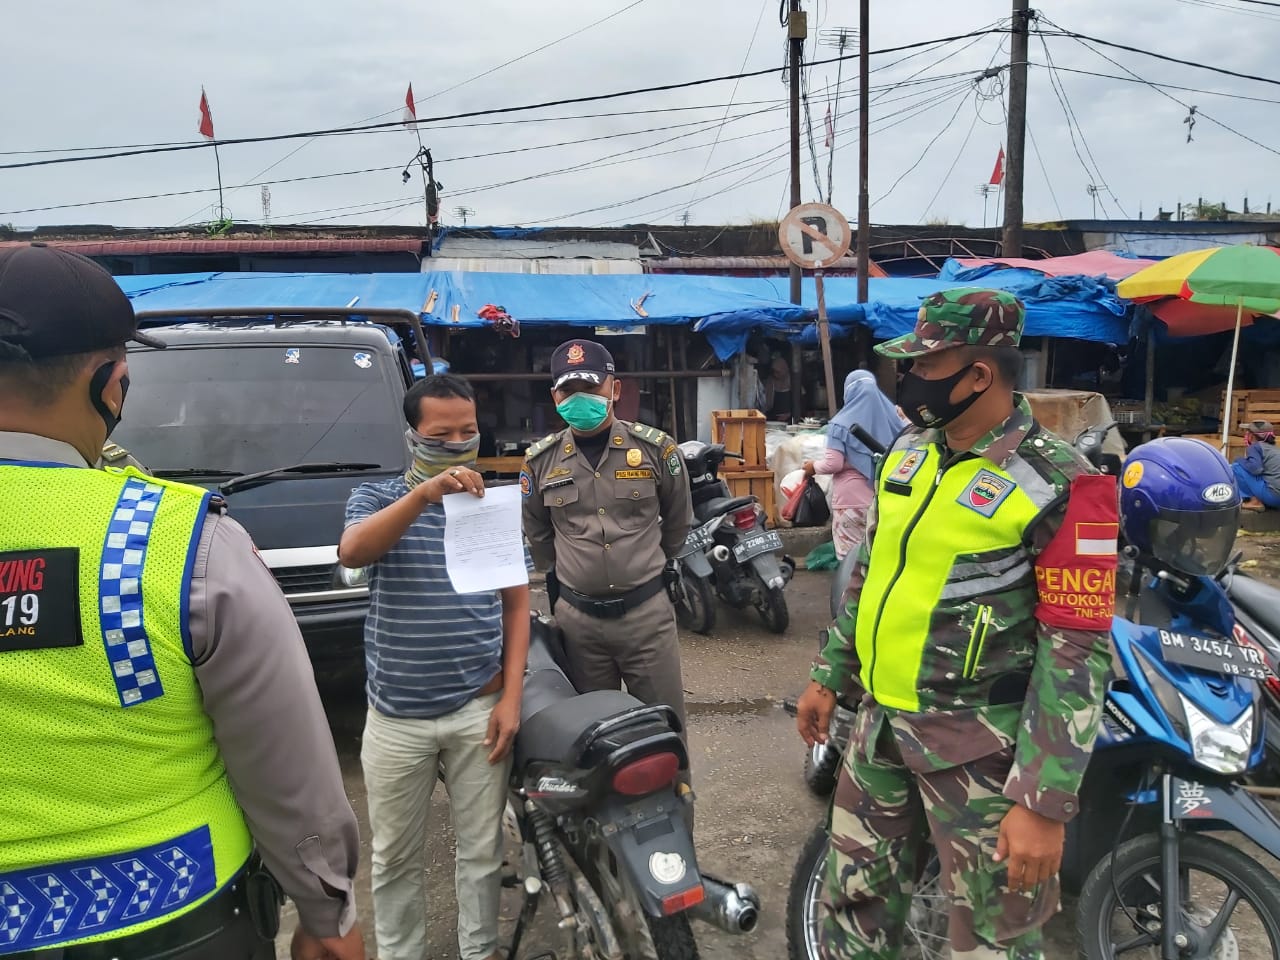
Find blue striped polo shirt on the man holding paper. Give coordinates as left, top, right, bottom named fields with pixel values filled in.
left=346, top=476, right=527, bottom=719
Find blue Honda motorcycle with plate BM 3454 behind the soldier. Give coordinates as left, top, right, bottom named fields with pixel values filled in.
left=787, top=557, right=1280, bottom=960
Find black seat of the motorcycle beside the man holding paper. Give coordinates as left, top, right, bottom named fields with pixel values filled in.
left=516, top=686, right=641, bottom=767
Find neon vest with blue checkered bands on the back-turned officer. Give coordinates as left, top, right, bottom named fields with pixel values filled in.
left=0, top=462, right=252, bottom=955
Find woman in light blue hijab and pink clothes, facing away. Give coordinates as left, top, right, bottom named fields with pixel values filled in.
left=804, top=370, right=906, bottom=559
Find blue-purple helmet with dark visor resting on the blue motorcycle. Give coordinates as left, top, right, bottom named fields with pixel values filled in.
left=1120, top=436, right=1240, bottom=576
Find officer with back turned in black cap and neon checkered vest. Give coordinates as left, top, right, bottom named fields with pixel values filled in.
left=0, top=244, right=365, bottom=960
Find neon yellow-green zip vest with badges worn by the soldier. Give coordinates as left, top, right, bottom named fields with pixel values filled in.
left=855, top=434, right=1060, bottom=712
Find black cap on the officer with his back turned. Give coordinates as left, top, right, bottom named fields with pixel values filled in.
left=0, top=243, right=165, bottom=361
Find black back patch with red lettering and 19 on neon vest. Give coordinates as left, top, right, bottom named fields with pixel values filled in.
left=0, top=547, right=84, bottom=653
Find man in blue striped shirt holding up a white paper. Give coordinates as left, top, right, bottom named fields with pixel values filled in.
left=338, top=375, right=529, bottom=960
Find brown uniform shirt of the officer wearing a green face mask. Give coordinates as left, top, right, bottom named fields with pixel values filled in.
left=520, top=420, right=694, bottom=596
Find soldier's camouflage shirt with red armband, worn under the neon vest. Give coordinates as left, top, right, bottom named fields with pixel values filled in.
left=810, top=397, right=1117, bottom=820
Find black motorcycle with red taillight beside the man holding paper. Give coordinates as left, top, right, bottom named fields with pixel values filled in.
left=506, top=616, right=760, bottom=960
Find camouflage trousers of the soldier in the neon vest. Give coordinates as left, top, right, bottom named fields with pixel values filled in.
left=820, top=709, right=1057, bottom=960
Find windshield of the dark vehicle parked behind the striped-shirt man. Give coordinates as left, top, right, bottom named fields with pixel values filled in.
left=113, top=344, right=407, bottom=476
